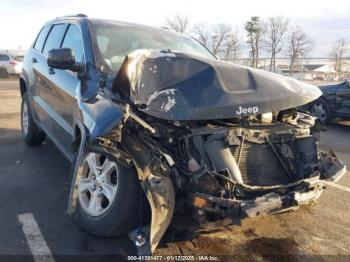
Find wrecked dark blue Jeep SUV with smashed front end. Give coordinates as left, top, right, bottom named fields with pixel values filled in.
left=20, top=15, right=346, bottom=253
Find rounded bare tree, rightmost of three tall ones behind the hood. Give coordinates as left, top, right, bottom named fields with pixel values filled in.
left=288, top=27, right=312, bottom=76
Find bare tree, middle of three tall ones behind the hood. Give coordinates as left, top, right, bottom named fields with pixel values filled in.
left=264, top=16, right=289, bottom=72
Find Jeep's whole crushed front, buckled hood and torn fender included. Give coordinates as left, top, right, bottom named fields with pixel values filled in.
left=81, top=50, right=346, bottom=252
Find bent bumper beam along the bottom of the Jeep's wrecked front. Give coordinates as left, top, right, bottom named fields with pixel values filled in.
left=192, top=162, right=346, bottom=217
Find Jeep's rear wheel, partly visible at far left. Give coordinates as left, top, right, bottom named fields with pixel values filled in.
left=21, top=93, right=46, bottom=145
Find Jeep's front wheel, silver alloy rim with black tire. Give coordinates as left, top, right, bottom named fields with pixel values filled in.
left=76, top=148, right=144, bottom=237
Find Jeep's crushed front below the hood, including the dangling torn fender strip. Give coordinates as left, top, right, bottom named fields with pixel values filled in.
left=117, top=105, right=346, bottom=253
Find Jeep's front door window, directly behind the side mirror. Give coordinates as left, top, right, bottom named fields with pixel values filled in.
left=62, top=24, right=84, bottom=63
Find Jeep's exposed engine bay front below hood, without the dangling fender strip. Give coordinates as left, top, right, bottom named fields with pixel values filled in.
left=137, top=110, right=346, bottom=223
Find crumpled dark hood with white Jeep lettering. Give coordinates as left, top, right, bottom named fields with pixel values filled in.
left=116, top=50, right=322, bottom=120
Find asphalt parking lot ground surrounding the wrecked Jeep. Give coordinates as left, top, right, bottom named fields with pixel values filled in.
left=0, top=80, right=350, bottom=261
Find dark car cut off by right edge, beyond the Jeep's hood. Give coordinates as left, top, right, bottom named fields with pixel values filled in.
left=309, top=80, right=350, bottom=124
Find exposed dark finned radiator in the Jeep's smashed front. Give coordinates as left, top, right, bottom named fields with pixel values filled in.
left=231, top=141, right=289, bottom=186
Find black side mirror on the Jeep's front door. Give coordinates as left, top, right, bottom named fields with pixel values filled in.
left=47, top=48, right=83, bottom=72
